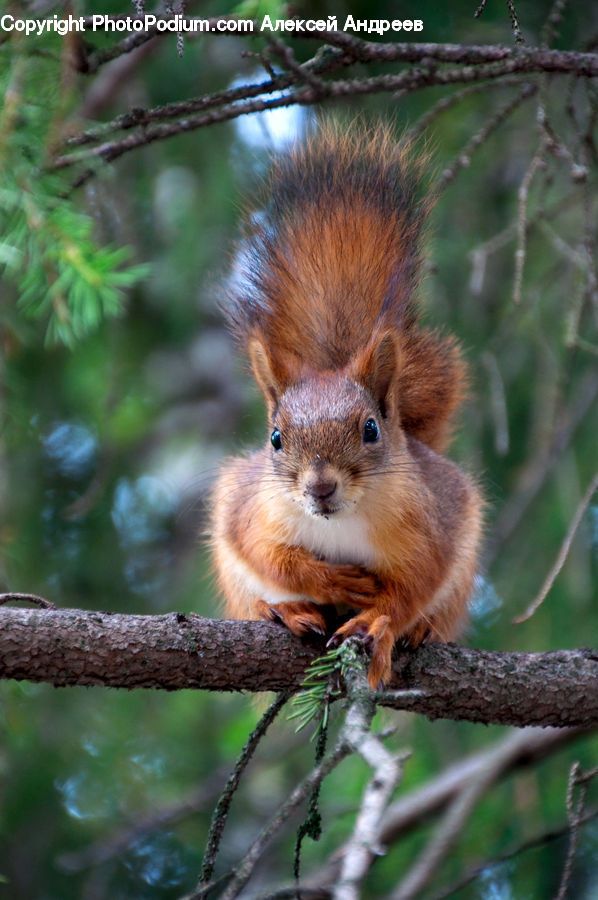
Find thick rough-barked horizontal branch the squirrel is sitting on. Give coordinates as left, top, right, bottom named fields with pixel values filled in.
left=0, top=607, right=598, bottom=727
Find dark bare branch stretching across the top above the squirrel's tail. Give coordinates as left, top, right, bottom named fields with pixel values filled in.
left=50, top=40, right=598, bottom=178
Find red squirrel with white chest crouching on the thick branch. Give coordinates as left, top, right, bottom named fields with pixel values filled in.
left=212, top=124, right=482, bottom=689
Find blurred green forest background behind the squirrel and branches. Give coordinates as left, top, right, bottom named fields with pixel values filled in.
left=0, top=0, right=598, bottom=900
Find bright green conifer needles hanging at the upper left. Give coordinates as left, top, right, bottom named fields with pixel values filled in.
left=0, top=35, right=148, bottom=345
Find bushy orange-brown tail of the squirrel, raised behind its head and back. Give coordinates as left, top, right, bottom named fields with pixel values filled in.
left=227, top=123, right=464, bottom=449
